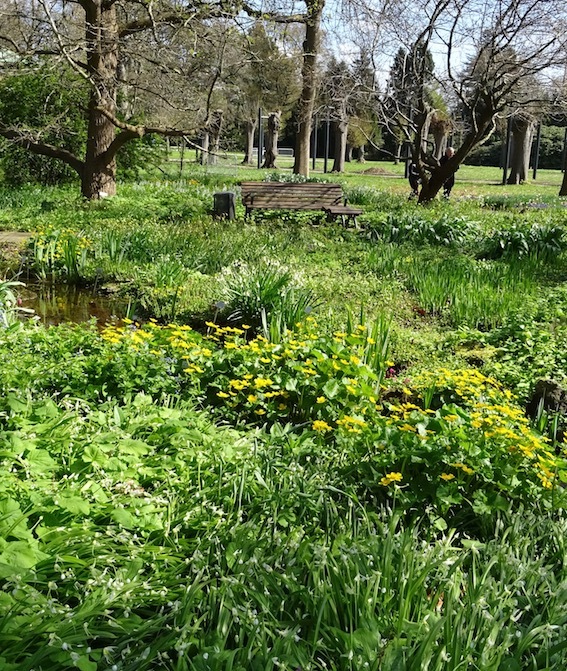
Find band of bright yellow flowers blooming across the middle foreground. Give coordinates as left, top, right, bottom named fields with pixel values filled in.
left=98, top=320, right=557, bottom=498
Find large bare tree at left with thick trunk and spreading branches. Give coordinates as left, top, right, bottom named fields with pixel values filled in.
left=0, top=0, right=253, bottom=199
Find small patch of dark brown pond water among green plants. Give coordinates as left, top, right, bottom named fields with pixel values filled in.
left=18, top=285, right=130, bottom=326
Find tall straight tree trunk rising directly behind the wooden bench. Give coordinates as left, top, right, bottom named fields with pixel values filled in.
left=293, top=0, right=325, bottom=177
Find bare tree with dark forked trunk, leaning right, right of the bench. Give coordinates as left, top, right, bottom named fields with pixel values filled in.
left=404, top=0, right=567, bottom=202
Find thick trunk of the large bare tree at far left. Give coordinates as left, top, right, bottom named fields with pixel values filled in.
left=81, top=1, right=118, bottom=200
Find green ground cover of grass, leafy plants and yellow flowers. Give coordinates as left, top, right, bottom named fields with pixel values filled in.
left=0, top=164, right=567, bottom=671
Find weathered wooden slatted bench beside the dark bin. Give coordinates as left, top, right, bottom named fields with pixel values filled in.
left=241, top=182, right=362, bottom=225
